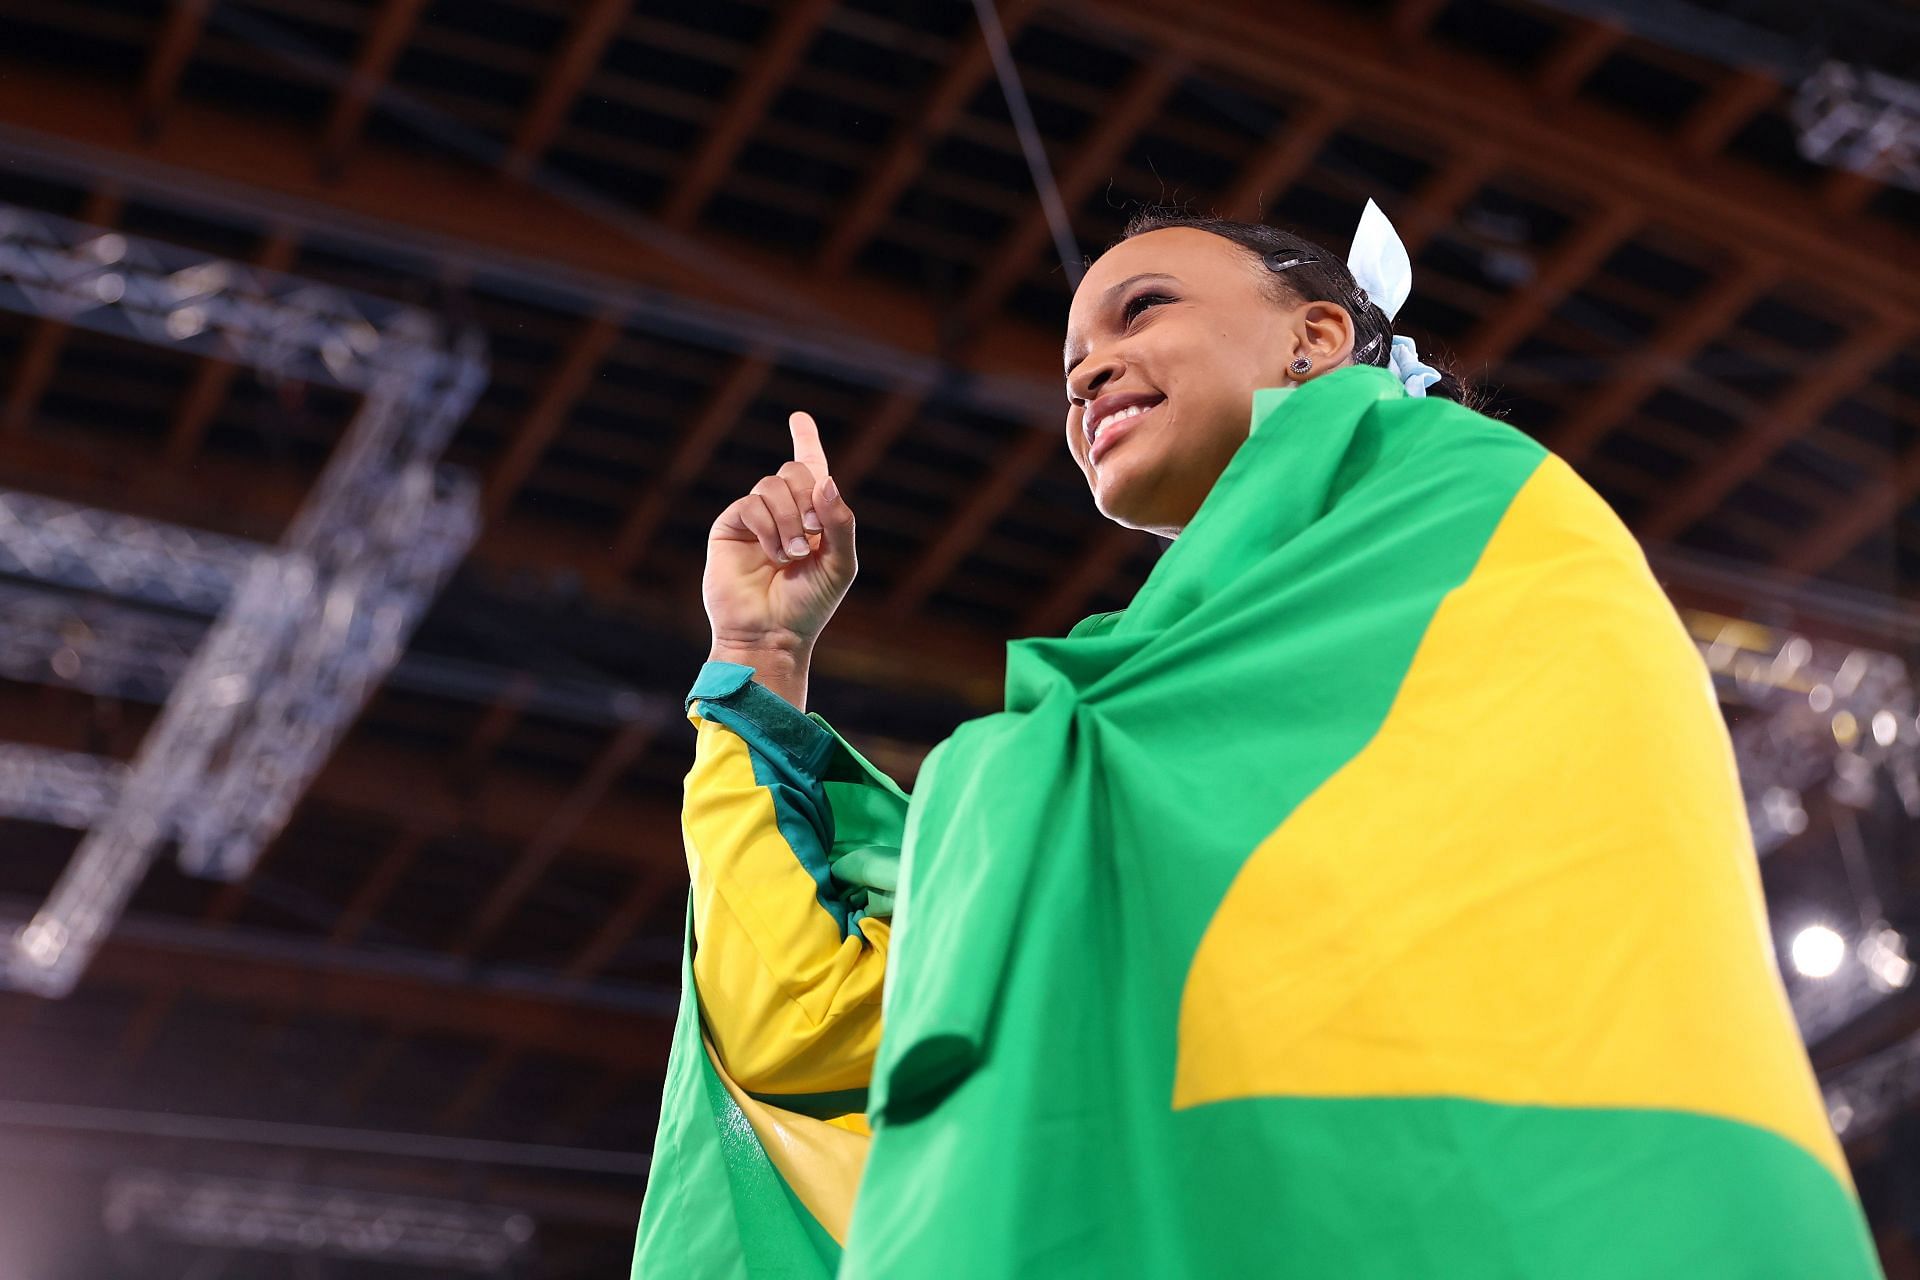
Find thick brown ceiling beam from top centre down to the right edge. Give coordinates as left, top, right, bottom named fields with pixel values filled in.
left=1075, top=0, right=1920, bottom=319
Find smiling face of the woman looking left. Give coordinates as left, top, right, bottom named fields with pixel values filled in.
left=1066, top=226, right=1346, bottom=537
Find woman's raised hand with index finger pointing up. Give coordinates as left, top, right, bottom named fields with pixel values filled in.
left=701, top=413, right=858, bottom=683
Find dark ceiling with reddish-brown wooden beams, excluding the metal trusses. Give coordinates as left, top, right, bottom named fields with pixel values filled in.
left=0, top=0, right=1920, bottom=1276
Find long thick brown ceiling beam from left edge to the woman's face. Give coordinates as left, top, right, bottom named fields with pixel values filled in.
left=0, top=61, right=1060, bottom=416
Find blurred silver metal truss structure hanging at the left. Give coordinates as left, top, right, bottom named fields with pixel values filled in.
left=0, top=205, right=486, bottom=996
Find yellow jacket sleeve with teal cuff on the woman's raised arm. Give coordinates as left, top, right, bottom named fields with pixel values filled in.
left=682, top=662, right=906, bottom=1111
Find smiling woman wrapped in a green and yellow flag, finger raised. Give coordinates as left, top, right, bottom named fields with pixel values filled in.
left=636, top=205, right=1878, bottom=1280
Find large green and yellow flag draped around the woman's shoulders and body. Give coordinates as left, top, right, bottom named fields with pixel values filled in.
left=643, top=368, right=1878, bottom=1280
